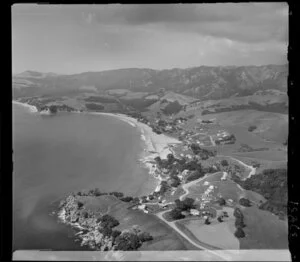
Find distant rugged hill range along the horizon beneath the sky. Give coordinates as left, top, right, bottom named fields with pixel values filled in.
left=13, top=65, right=288, bottom=102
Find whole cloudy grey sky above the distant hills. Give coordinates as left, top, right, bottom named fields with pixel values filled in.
left=12, top=2, right=289, bottom=74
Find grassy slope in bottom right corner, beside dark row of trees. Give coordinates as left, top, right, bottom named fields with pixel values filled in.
left=240, top=207, right=288, bottom=249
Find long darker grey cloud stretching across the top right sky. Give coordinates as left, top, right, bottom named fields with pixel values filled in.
left=91, top=3, right=288, bottom=42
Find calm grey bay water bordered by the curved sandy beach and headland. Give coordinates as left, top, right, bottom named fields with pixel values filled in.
left=13, top=104, right=155, bottom=250
